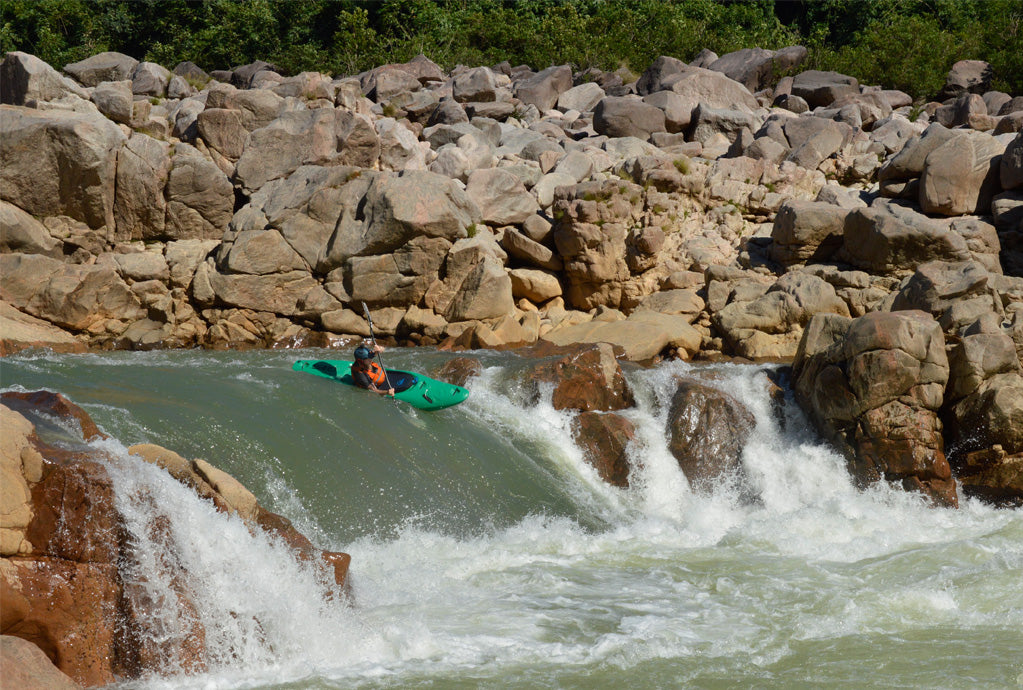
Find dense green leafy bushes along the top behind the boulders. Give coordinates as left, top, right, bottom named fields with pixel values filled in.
left=0, top=0, right=1023, bottom=99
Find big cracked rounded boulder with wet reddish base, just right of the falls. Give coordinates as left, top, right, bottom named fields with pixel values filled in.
left=793, top=311, right=958, bottom=506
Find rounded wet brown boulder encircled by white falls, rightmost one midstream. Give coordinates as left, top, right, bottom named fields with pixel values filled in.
left=667, top=379, right=756, bottom=490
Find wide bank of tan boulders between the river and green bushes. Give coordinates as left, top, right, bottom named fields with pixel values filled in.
left=0, top=46, right=1023, bottom=504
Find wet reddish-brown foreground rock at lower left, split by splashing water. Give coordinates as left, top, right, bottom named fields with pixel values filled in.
left=0, top=392, right=350, bottom=687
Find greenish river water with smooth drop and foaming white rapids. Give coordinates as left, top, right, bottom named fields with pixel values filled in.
left=0, top=350, right=1023, bottom=688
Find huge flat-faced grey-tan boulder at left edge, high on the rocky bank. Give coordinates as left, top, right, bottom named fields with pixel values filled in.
left=0, top=105, right=127, bottom=230
